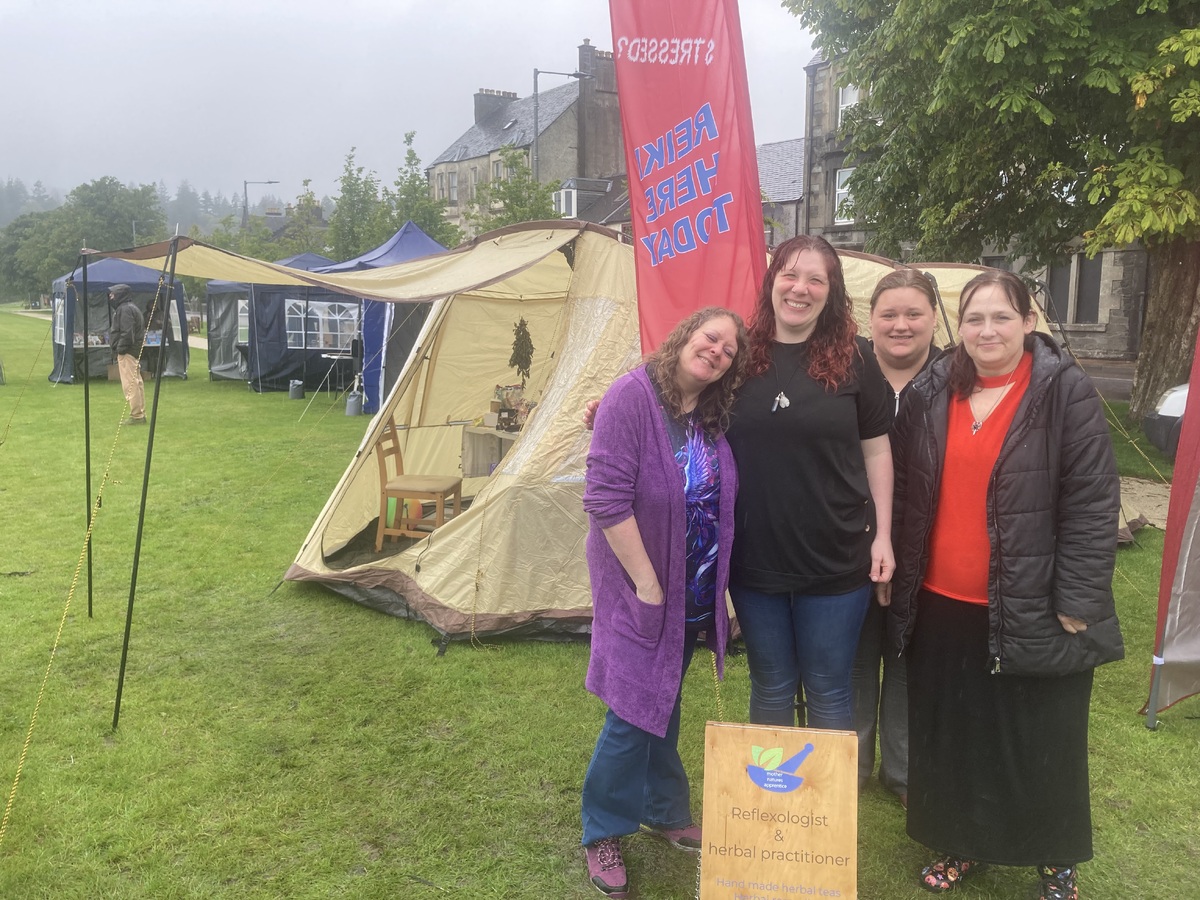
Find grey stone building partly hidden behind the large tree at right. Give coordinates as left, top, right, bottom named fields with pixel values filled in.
left=800, top=54, right=1147, bottom=359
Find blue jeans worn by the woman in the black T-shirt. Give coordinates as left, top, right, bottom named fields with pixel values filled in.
left=730, top=583, right=871, bottom=731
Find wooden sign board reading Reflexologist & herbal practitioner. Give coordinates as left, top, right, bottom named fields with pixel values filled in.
left=700, top=722, right=858, bottom=900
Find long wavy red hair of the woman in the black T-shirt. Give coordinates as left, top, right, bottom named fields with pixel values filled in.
left=748, top=234, right=858, bottom=390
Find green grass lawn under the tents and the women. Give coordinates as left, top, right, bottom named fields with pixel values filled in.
left=0, top=310, right=1200, bottom=900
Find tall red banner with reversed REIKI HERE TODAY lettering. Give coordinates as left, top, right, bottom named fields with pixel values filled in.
left=608, top=0, right=767, bottom=352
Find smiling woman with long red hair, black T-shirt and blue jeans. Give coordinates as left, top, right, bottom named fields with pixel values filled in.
left=727, top=235, right=893, bottom=731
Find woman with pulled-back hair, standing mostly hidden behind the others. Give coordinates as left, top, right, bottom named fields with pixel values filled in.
left=852, top=269, right=942, bottom=805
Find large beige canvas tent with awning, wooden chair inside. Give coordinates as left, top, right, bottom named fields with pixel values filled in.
left=98, top=221, right=1041, bottom=637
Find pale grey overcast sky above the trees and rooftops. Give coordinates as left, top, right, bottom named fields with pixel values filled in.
left=0, top=0, right=812, bottom=202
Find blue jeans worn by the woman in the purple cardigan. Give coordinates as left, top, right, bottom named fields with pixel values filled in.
left=583, top=635, right=696, bottom=846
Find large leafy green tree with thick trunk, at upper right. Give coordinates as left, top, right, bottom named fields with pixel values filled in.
left=784, top=0, right=1200, bottom=415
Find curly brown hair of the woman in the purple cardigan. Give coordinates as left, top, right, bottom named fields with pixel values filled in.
left=646, top=306, right=750, bottom=437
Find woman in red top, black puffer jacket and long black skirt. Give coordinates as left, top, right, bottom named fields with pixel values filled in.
left=889, top=272, right=1124, bottom=900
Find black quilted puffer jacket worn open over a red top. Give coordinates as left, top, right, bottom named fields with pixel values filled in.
left=888, top=334, right=1124, bottom=676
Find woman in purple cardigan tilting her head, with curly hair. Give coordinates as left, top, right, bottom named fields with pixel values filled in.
left=582, top=306, right=746, bottom=898
